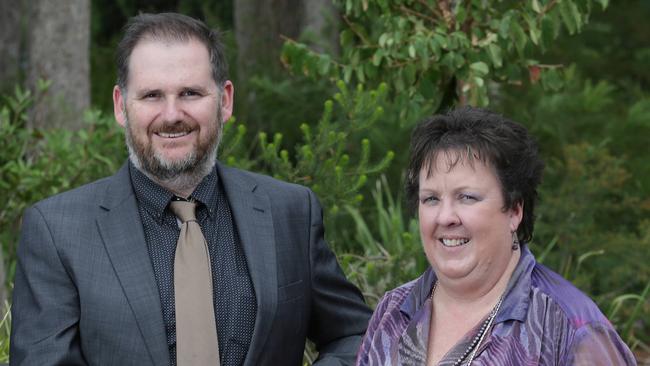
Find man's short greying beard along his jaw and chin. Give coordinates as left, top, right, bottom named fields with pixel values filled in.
left=124, top=105, right=224, bottom=192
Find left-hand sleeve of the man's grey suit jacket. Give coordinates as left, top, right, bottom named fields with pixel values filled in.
left=10, top=207, right=86, bottom=365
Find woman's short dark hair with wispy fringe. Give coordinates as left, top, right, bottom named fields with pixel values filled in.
left=406, top=107, right=544, bottom=242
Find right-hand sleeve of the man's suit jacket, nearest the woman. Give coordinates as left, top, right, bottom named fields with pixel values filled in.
left=309, top=191, right=371, bottom=366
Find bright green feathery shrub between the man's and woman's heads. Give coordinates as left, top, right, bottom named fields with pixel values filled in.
left=221, top=81, right=395, bottom=246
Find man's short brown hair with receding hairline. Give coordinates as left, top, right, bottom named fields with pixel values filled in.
left=116, top=13, right=228, bottom=91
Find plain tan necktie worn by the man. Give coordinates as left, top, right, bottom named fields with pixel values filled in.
left=170, top=201, right=219, bottom=366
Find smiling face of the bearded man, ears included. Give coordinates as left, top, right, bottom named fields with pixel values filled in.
left=113, top=39, right=233, bottom=179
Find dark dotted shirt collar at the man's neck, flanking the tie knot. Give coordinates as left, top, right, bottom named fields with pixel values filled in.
left=129, top=161, right=219, bottom=221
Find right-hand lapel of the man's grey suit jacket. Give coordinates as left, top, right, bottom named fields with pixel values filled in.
left=217, top=163, right=278, bottom=365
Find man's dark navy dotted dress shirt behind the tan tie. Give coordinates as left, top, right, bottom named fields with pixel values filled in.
left=129, top=163, right=257, bottom=366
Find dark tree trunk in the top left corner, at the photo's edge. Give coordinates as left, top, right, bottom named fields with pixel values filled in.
left=0, top=0, right=23, bottom=94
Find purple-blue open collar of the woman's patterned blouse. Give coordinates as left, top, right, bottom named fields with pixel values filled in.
left=400, top=245, right=537, bottom=322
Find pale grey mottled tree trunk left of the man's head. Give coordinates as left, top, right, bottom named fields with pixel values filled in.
left=27, top=0, right=90, bottom=129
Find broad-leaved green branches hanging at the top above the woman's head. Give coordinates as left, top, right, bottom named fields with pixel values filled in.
left=283, top=0, right=607, bottom=122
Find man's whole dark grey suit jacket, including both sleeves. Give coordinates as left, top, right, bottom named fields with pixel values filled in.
left=11, top=164, right=370, bottom=365
